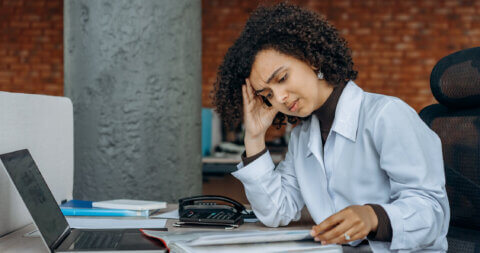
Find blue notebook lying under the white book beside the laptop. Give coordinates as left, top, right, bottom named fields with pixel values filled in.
left=60, top=200, right=152, bottom=217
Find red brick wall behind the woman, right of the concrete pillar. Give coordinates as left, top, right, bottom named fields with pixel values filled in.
left=202, top=0, right=480, bottom=111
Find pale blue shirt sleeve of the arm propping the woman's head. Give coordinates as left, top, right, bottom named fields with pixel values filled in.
left=232, top=134, right=305, bottom=227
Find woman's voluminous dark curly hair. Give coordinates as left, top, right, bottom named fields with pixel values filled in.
left=213, top=2, right=357, bottom=128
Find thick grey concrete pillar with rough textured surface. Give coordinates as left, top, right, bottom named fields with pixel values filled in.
left=64, top=0, right=202, bottom=201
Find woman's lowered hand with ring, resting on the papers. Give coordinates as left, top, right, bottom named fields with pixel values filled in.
left=310, top=205, right=378, bottom=244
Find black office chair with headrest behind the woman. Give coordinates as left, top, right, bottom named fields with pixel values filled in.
left=420, top=47, right=480, bottom=252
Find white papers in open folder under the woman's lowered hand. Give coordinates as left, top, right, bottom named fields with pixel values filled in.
left=142, top=230, right=342, bottom=253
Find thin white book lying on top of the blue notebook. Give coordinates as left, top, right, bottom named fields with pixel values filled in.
left=92, top=199, right=167, bottom=210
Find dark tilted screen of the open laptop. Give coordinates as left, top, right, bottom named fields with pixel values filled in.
left=0, top=149, right=68, bottom=249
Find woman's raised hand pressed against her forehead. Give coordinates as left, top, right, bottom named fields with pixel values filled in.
left=242, top=78, right=278, bottom=157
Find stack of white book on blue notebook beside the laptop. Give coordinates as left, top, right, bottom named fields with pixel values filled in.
left=60, top=199, right=167, bottom=217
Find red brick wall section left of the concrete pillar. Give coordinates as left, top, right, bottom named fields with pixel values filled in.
left=0, top=0, right=63, bottom=96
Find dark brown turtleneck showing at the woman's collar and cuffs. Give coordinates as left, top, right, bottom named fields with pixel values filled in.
left=242, top=82, right=393, bottom=242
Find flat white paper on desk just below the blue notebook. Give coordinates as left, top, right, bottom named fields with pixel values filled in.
left=67, top=218, right=167, bottom=229
